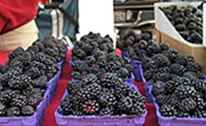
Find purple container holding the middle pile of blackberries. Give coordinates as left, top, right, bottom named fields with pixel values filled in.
left=55, top=80, right=146, bottom=126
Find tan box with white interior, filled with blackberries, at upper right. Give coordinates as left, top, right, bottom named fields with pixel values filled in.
left=155, top=2, right=206, bottom=71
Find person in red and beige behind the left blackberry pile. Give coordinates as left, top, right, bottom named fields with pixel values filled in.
left=0, top=0, right=47, bottom=51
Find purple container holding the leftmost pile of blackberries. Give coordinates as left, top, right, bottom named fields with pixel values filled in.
left=0, top=62, right=63, bottom=126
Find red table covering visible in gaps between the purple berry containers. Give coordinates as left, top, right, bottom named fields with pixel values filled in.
left=0, top=50, right=158, bottom=126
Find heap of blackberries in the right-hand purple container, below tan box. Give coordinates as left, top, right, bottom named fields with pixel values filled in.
left=118, top=32, right=206, bottom=118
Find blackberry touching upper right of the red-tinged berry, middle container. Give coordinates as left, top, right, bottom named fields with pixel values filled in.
left=99, top=93, right=117, bottom=106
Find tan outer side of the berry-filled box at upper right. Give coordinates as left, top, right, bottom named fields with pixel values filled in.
left=155, top=29, right=206, bottom=72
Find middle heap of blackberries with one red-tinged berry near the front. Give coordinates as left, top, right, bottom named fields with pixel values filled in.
left=58, top=33, right=144, bottom=116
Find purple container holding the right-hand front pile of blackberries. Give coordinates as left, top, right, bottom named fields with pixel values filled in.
left=148, top=82, right=206, bottom=126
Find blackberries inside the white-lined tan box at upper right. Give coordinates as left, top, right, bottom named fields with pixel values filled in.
left=161, top=5, right=203, bottom=44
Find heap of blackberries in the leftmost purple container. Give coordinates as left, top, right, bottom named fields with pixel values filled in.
left=0, top=38, right=66, bottom=116
